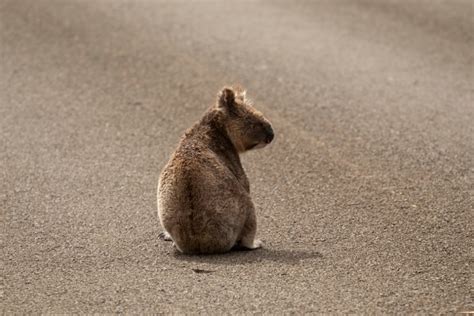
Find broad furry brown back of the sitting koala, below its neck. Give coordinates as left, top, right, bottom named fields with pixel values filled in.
left=158, top=142, right=252, bottom=253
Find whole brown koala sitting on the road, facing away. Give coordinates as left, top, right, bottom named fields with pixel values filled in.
left=157, top=87, right=274, bottom=254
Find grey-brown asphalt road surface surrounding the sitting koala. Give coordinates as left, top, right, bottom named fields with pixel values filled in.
left=0, top=0, right=474, bottom=314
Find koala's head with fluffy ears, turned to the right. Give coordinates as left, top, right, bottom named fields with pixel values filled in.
left=216, top=87, right=274, bottom=152
